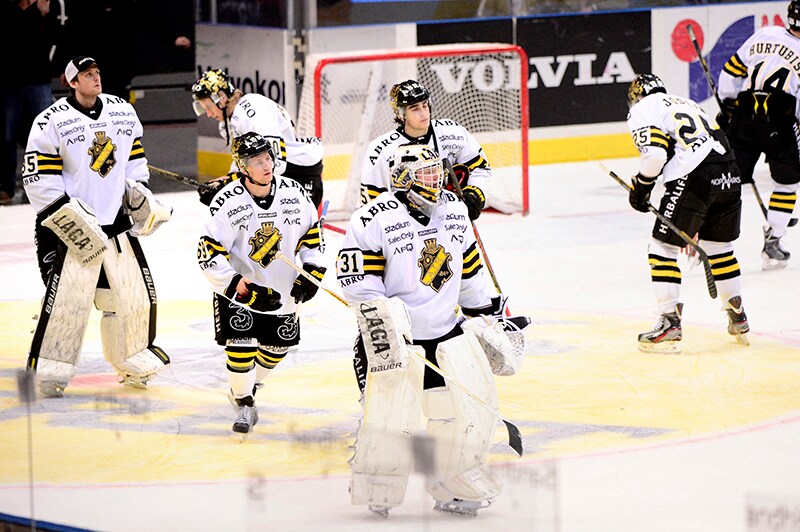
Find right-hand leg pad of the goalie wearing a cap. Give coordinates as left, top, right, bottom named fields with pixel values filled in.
left=95, top=234, right=169, bottom=384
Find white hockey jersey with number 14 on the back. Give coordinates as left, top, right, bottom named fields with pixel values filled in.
left=718, top=26, right=800, bottom=117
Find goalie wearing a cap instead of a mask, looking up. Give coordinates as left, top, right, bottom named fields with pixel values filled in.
left=23, top=56, right=172, bottom=397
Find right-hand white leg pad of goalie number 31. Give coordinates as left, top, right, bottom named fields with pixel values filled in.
left=423, top=334, right=502, bottom=501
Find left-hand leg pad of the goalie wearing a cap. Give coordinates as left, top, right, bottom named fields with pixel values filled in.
left=28, top=249, right=101, bottom=395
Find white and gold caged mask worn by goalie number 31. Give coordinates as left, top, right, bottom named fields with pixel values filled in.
left=389, top=144, right=444, bottom=217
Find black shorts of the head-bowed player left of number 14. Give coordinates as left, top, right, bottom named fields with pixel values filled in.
left=653, top=162, right=742, bottom=247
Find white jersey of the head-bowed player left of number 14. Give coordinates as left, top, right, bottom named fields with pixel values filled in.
left=628, top=92, right=726, bottom=182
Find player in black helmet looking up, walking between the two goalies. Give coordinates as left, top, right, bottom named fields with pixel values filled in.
left=197, top=132, right=325, bottom=435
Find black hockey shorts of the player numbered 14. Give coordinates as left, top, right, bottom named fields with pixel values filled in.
left=727, top=115, right=800, bottom=185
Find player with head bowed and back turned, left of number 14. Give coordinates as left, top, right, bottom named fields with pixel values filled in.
left=628, top=74, right=750, bottom=352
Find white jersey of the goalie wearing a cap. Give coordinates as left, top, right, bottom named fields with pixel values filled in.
left=22, top=94, right=150, bottom=225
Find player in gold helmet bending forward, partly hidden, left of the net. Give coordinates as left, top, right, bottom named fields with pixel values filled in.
left=192, top=69, right=323, bottom=208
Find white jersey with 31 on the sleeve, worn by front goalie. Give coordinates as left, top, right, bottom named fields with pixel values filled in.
left=336, top=191, right=497, bottom=340
